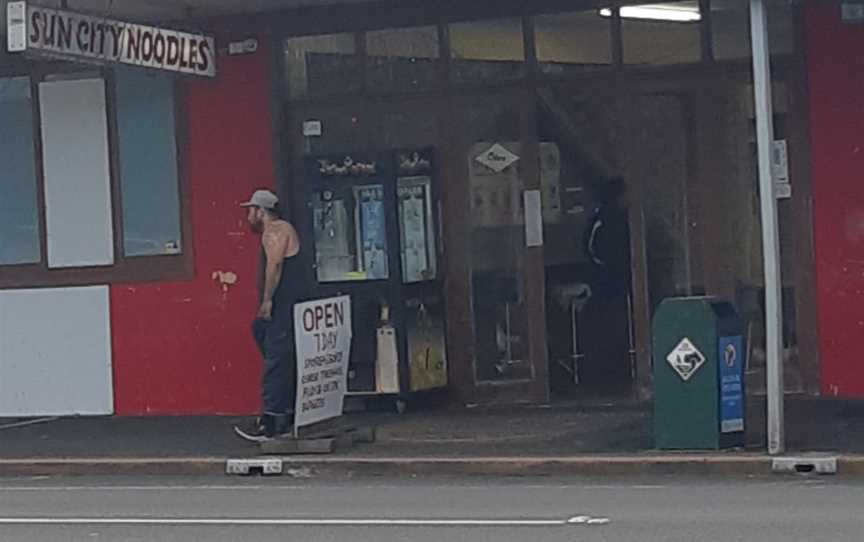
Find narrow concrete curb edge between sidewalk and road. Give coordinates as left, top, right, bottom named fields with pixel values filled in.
left=0, top=454, right=864, bottom=477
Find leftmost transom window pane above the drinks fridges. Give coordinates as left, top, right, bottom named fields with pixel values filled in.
left=284, top=34, right=362, bottom=98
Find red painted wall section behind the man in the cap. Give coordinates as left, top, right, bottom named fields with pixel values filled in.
left=111, top=40, right=273, bottom=415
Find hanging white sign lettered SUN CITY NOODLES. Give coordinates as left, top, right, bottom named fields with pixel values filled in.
left=6, top=2, right=216, bottom=77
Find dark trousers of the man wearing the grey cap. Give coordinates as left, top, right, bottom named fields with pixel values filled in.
left=252, top=306, right=297, bottom=424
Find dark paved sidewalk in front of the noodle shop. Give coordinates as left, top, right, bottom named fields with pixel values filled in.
left=0, top=396, right=864, bottom=474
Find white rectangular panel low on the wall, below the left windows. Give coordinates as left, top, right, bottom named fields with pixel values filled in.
left=0, top=286, right=114, bottom=417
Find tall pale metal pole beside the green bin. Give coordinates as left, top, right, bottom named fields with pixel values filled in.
left=750, top=0, right=785, bottom=455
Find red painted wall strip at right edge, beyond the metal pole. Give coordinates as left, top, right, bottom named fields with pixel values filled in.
left=805, top=2, right=864, bottom=397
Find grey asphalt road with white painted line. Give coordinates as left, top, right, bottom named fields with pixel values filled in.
left=0, top=477, right=864, bottom=542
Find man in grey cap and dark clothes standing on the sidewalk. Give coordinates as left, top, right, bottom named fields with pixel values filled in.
left=235, top=190, right=303, bottom=442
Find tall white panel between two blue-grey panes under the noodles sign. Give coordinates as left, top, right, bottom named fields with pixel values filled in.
left=39, top=79, right=114, bottom=268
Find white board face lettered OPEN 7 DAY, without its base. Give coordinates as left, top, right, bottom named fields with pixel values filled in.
left=294, top=296, right=351, bottom=434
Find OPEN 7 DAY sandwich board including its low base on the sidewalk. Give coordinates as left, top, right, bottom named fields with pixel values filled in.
left=261, top=296, right=375, bottom=454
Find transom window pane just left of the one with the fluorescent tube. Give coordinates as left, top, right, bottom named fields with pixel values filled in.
left=534, top=11, right=612, bottom=74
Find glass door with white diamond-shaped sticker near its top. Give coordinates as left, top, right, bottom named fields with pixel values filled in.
left=454, top=91, right=547, bottom=402
